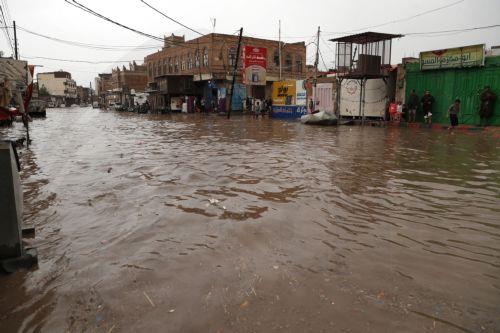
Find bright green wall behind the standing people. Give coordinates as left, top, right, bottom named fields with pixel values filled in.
left=405, top=56, right=500, bottom=126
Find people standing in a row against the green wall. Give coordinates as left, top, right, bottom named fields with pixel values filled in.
left=390, top=86, right=497, bottom=127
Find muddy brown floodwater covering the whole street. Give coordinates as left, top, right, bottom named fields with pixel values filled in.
left=0, top=108, right=500, bottom=333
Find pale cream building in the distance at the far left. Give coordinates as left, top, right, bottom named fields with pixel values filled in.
left=37, top=71, right=77, bottom=104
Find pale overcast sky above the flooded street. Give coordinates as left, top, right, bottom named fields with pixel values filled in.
left=0, top=0, right=500, bottom=86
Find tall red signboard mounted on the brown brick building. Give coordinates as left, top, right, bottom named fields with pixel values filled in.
left=243, top=46, right=267, bottom=86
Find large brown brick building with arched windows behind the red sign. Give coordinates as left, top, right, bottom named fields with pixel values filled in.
left=144, top=33, right=306, bottom=108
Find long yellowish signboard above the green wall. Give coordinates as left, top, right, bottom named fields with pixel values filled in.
left=420, top=44, right=485, bottom=70
